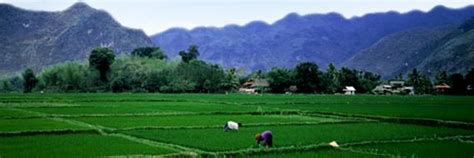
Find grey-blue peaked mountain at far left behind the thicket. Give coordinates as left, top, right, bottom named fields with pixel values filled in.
left=0, top=3, right=154, bottom=74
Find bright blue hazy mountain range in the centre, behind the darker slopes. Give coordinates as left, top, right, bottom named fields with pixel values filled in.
left=151, top=6, right=474, bottom=70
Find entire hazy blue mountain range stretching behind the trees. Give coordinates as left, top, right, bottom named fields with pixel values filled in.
left=0, top=3, right=474, bottom=78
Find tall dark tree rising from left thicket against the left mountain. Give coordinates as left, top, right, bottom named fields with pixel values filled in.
left=89, top=48, right=115, bottom=82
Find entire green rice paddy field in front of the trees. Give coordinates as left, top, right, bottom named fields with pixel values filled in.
left=0, top=94, right=474, bottom=158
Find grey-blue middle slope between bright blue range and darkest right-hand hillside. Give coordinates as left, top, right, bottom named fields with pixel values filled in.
left=344, top=26, right=456, bottom=77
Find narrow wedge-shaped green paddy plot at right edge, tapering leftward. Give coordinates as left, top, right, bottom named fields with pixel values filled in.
left=266, top=102, right=474, bottom=122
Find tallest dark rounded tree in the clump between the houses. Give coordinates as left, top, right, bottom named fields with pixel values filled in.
left=295, top=62, right=321, bottom=93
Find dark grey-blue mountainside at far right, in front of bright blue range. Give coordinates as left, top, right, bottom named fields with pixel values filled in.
left=344, top=17, right=474, bottom=78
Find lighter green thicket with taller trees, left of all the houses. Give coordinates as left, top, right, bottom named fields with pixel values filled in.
left=0, top=45, right=235, bottom=93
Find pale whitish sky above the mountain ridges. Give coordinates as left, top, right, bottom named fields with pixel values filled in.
left=0, top=0, right=474, bottom=35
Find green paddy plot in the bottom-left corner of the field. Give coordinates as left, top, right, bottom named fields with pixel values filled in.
left=0, top=134, right=173, bottom=158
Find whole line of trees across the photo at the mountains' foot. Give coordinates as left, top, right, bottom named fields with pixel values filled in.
left=0, top=45, right=474, bottom=95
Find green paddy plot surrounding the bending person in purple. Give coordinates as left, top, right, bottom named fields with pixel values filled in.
left=120, top=123, right=474, bottom=151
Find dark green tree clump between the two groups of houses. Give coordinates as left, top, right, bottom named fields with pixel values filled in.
left=266, top=62, right=381, bottom=94
